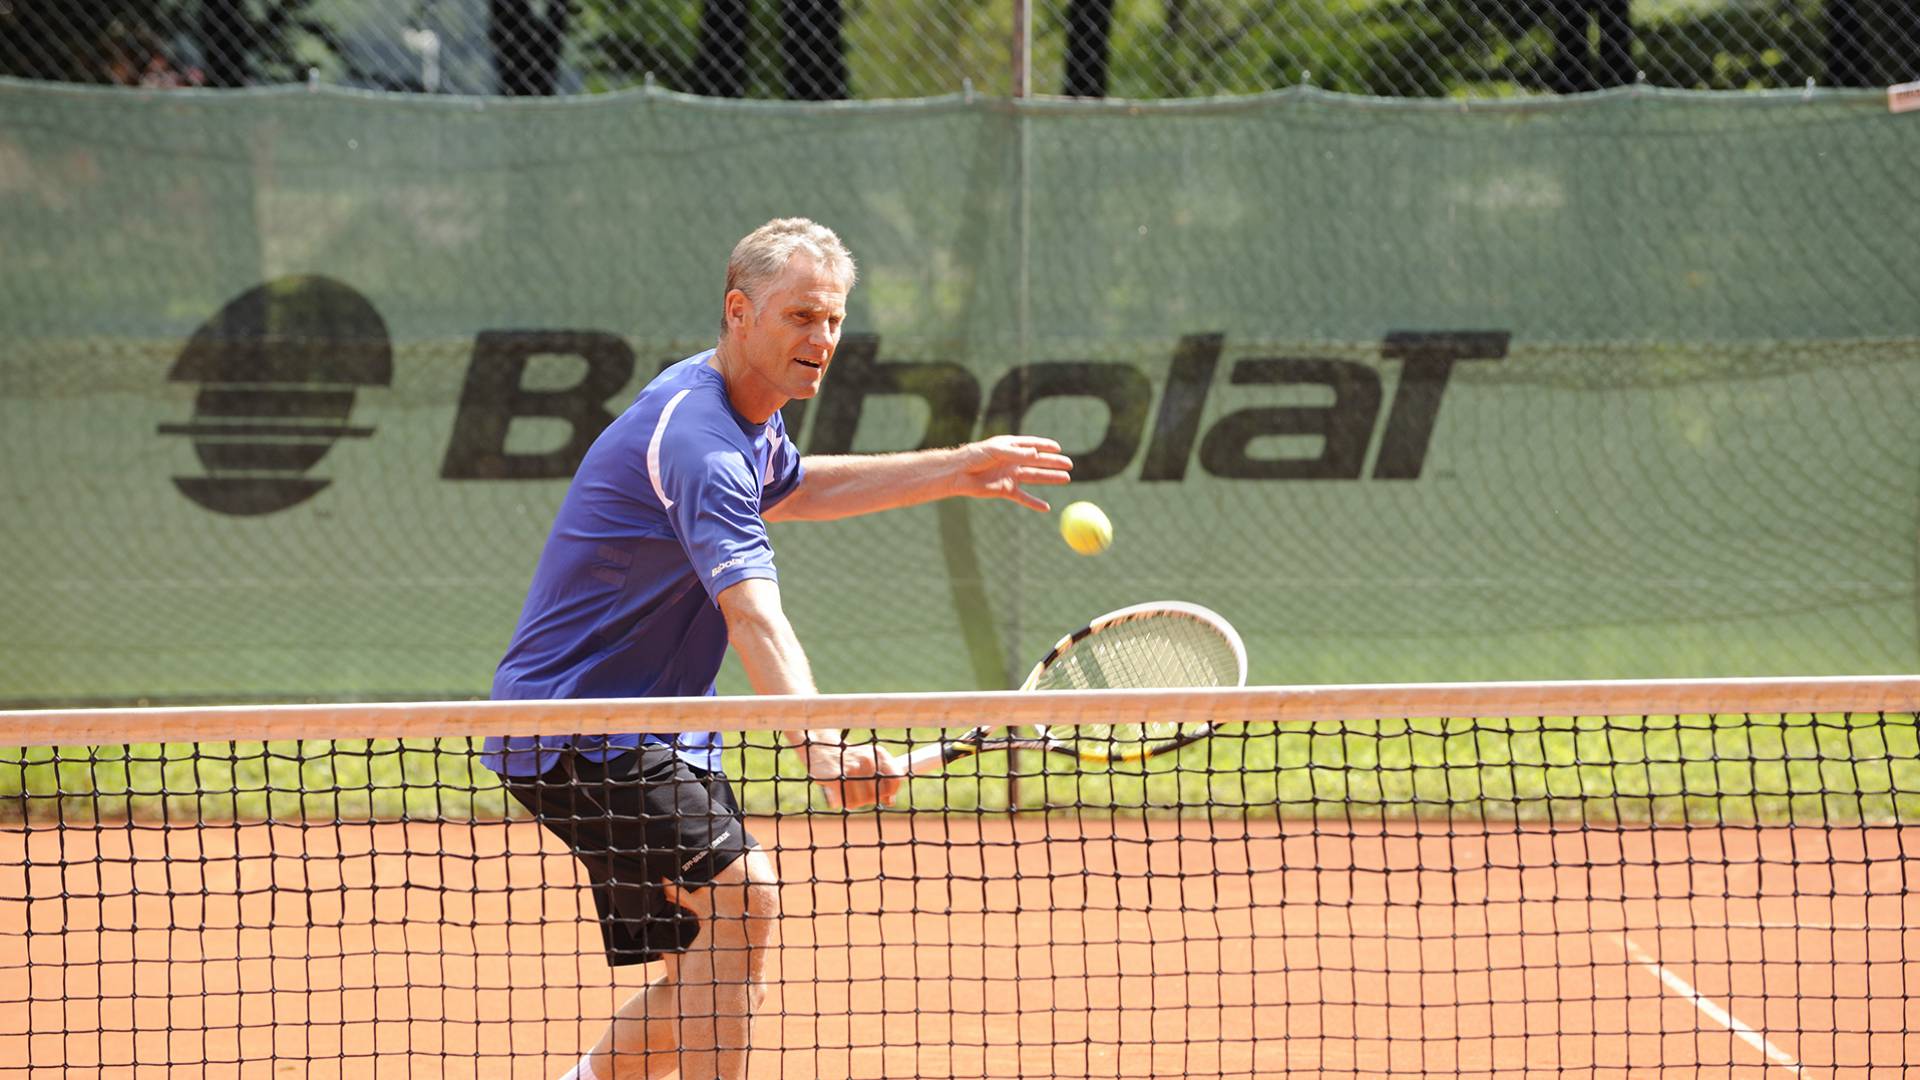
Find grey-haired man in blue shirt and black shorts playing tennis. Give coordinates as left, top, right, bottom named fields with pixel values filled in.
left=482, top=217, right=1073, bottom=1080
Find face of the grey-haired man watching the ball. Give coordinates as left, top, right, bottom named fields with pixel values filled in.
left=726, top=252, right=847, bottom=409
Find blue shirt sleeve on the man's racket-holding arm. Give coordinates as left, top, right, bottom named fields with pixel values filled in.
left=659, top=418, right=780, bottom=598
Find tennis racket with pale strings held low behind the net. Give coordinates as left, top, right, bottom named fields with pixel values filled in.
left=906, top=600, right=1246, bottom=773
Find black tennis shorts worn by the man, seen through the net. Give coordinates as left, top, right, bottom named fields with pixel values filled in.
left=501, top=744, right=758, bottom=967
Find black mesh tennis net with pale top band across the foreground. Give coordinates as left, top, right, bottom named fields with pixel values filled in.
left=0, top=678, right=1920, bottom=1078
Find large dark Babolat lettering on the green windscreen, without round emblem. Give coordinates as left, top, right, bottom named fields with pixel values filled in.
left=440, top=331, right=1509, bottom=482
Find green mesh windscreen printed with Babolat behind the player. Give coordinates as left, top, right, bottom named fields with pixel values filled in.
left=0, top=81, right=1920, bottom=703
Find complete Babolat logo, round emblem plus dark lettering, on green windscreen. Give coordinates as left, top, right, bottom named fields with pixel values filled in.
left=159, top=277, right=1509, bottom=507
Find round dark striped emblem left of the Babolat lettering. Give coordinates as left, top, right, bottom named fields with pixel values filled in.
left=159, top=277, right=394, bottom=515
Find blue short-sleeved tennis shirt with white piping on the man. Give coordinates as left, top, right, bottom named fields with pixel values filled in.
left=480, top=350, right=801, bottom=776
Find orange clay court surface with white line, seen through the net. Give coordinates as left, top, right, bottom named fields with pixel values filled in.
left=0, top=815, right=1920, bottom=1080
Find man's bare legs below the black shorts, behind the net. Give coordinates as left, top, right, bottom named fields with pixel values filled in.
left=576, top=847, right=780, bottom=1080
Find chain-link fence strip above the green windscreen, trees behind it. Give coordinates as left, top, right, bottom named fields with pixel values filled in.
left=0, top=0, right=1920, bottom=100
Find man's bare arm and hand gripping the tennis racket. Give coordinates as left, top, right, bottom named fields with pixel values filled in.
left=718, top=578, right=904, bottom=807
